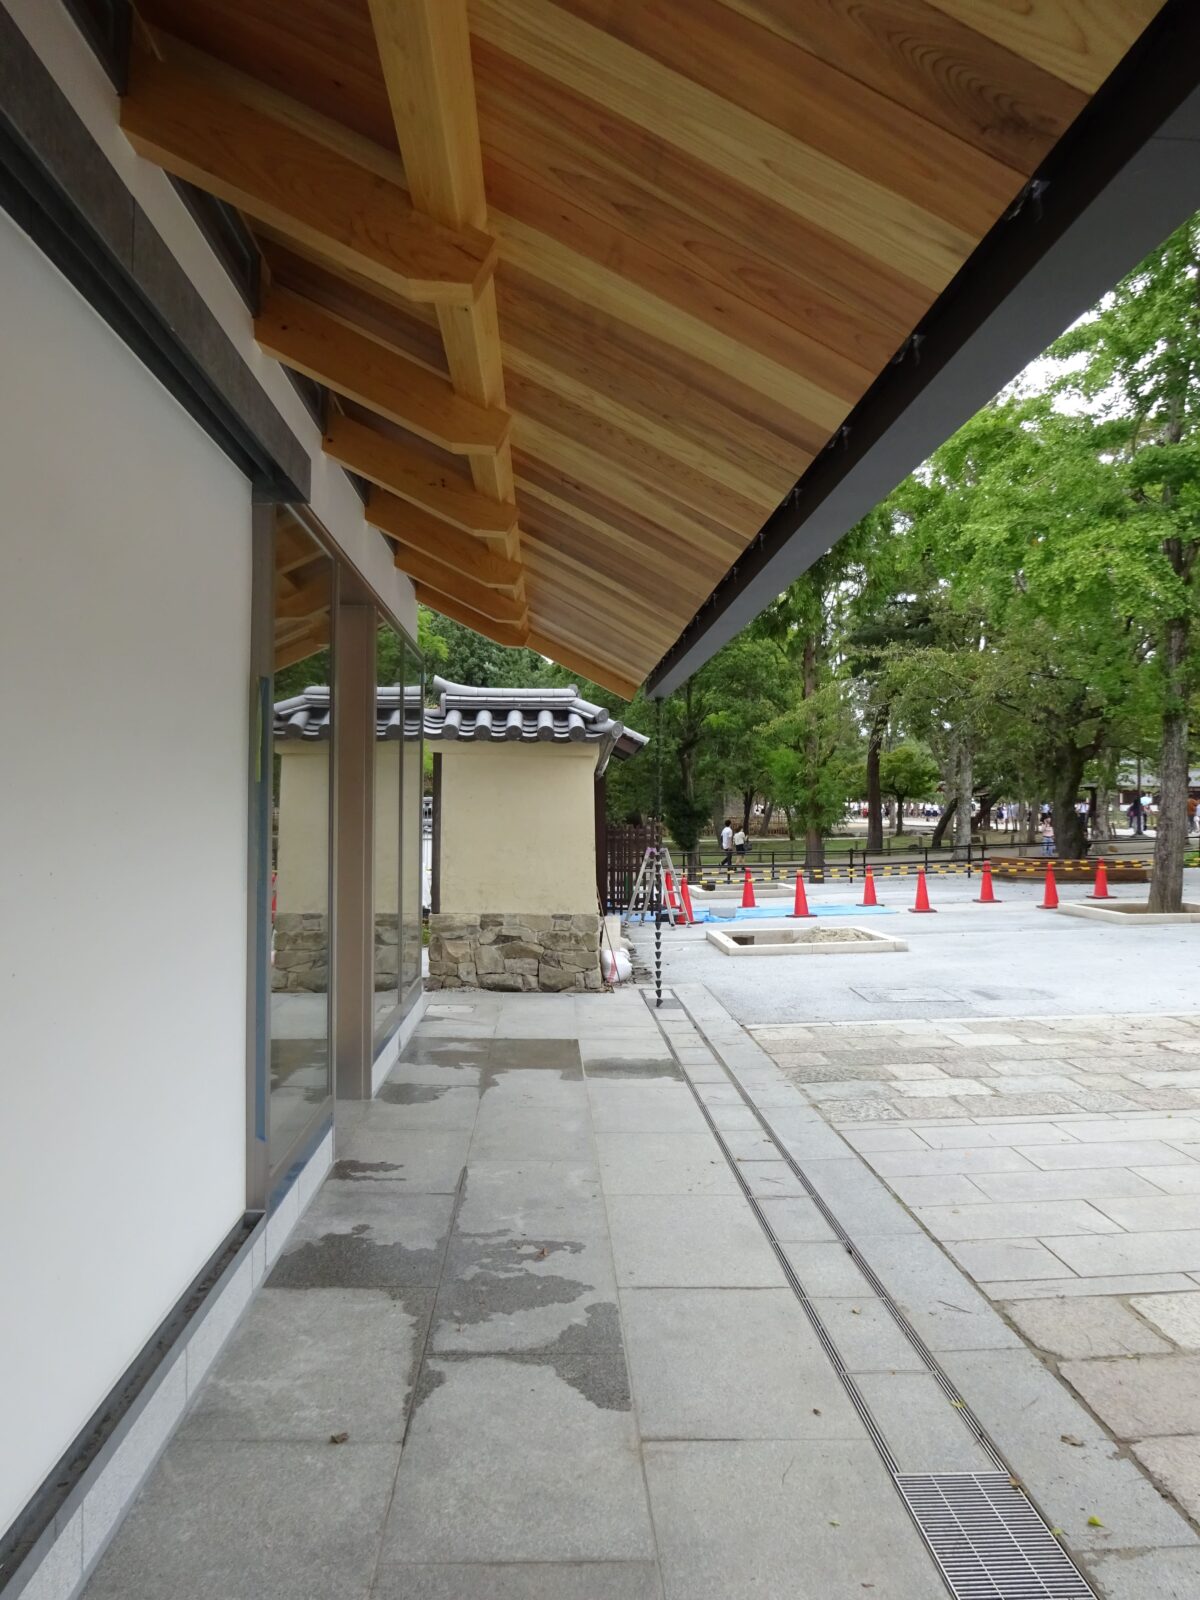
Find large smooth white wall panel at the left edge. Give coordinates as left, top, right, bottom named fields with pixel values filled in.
left=0, top=209, right=251, bottom=1528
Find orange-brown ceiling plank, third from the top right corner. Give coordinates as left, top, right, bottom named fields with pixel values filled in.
left=557, top=0, right=1029, bottom=235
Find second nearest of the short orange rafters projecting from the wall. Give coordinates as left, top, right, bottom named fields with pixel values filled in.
left=254, top=288, right=510, bottom=454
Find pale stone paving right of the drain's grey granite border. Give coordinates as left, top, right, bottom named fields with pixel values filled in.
left=752, top=1014, right=1200, bottom=1520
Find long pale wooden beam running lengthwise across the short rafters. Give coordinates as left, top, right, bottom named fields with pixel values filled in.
left=368, top=0, right=515, bottom=518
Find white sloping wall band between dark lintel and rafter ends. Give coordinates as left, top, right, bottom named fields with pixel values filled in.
left=3, top=0, right=416, bottom=638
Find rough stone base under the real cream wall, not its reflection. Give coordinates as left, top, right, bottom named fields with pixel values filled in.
left=429, top=912, right=602, bottom=990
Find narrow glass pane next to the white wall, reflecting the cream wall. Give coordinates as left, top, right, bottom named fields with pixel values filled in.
left=269, top=525, right=333, bottom=1166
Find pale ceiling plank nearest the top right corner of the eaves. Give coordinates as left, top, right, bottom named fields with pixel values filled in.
left=930, top=0, right=1163, bottom=94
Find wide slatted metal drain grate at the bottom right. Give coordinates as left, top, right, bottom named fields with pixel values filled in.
left=896, top=1472, right=1094, bottom=1600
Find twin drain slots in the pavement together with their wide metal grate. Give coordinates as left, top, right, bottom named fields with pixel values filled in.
left=646, top=997, right=1096, bottom=1600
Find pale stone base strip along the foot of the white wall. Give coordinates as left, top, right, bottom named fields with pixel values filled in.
left=3, top=1128, right=333, bottom=1600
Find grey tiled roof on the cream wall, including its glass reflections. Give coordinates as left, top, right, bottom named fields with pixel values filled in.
left=275, top=678, right=646, bottom=771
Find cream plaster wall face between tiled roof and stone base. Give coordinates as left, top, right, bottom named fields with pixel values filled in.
left=434, top=739, right=595, bottom=914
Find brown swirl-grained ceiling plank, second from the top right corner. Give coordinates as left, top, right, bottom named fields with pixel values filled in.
left=725, top=0, right=1083, bottom=173
